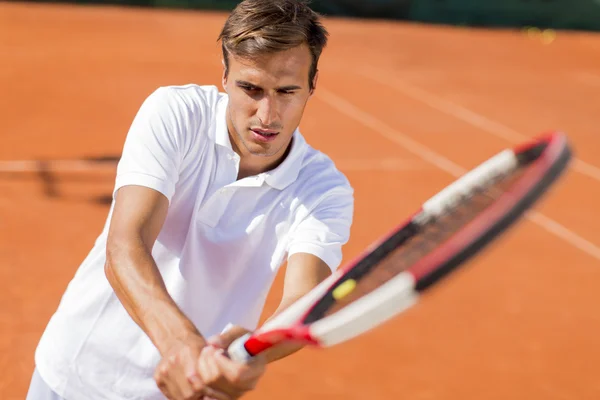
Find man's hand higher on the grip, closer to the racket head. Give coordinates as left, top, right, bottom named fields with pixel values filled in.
left=198, top=346, right=267, bottom=399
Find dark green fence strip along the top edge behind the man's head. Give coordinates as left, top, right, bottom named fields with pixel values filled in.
left=16, top=0, right=600, bottom=30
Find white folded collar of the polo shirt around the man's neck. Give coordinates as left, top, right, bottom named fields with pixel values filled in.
left=215, top=94, right=308, bottom=190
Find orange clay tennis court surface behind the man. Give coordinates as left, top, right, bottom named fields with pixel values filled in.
left=0, top=2, right=600, bottom=400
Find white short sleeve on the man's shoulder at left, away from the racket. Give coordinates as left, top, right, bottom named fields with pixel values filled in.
left=114, top=88, right=185, bottom=202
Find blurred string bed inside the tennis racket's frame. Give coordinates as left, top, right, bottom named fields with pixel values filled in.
left=321, top=168, right=523, bottom=316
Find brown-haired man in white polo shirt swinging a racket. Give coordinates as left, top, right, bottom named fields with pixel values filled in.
left=28, top=0, right=353, bottom=400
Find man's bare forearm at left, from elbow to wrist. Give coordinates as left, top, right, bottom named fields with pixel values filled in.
left=105, top=239, right=200, bottom=354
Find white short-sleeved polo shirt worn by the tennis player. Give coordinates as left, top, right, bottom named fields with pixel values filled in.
left=35, top=85, right=353, bottom=400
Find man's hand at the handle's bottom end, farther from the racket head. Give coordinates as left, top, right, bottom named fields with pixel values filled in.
left=154, top=334, right=231, bottom=400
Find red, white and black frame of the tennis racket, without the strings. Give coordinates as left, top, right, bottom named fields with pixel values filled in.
left=228, top=132, right=571, bottom=362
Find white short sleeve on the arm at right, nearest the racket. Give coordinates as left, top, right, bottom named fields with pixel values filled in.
left=288, top=188, right=354, bottom=271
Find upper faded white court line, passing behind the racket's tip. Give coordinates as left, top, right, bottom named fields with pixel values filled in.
left=358, top=68, right=600, bottom=182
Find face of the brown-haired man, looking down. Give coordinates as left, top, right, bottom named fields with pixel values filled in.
left=223, top=45, right=316, bottom=158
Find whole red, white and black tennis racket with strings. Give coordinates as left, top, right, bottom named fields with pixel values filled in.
left=228, top=133, right=571, bottom=362
